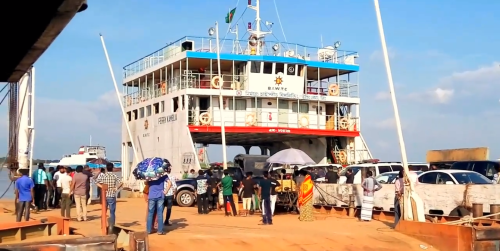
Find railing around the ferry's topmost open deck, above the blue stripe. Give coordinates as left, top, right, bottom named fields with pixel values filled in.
left=123, top=36, right=358, bottom=78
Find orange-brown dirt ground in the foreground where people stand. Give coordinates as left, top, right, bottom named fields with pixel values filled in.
left=0, top=199, right=436, bottom=251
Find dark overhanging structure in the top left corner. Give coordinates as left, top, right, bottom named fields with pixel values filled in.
left=0, top=0, right=87, bottom=82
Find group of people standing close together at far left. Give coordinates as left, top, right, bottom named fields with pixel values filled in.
left=11, top=163, right=122, bottom=224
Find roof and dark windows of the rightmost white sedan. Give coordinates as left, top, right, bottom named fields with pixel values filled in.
left=418, top=170, right=492, bottom=185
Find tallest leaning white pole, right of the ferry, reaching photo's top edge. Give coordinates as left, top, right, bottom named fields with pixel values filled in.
left=374, top=0, right=413, bottom=176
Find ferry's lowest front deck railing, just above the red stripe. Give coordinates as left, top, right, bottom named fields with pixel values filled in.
left=188, top=109, right=359, bottom=131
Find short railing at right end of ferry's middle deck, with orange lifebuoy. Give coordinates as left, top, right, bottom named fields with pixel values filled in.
left=306, top=80, right=359, bottom=98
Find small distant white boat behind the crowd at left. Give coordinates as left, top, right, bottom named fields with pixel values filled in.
left=46, top=146, right=121, bottom=172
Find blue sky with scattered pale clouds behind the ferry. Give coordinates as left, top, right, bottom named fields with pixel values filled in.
left=0, top=0, right=500, bottom=161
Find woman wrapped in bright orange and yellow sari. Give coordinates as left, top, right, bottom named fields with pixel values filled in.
left=298, top=169, right=314, bottom=221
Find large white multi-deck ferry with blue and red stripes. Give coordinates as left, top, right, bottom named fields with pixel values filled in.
left=122, top=0, right=372, bottom=179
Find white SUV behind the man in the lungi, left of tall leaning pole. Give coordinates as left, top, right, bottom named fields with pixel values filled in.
left=339, top=161, right=403, bottom=184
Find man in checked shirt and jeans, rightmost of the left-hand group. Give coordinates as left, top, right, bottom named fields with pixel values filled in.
left=96, top=163, right=123, bottom=231
